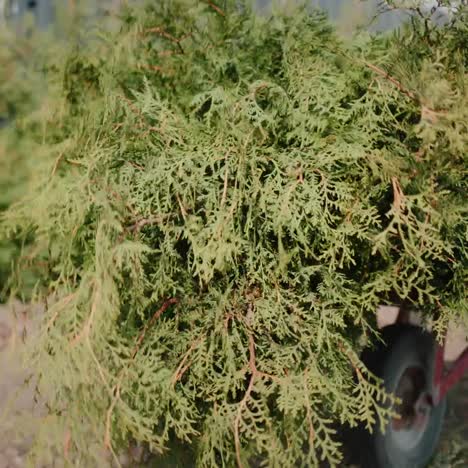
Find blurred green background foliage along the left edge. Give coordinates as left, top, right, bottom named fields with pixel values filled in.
left=0, top=0, right=122, bottom=301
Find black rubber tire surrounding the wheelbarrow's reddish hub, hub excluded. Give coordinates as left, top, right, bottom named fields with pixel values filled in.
left=353, top=325, right=446, bottom=468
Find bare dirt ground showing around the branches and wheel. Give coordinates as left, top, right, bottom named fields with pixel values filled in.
left=0, top=304, right=468, bottom=468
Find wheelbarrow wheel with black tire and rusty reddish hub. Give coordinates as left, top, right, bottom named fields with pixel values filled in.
left=355, top=324, right=446, bottom=468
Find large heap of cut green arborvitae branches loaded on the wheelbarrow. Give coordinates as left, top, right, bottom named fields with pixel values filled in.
left=3, top=0, right=468, bottom=467
